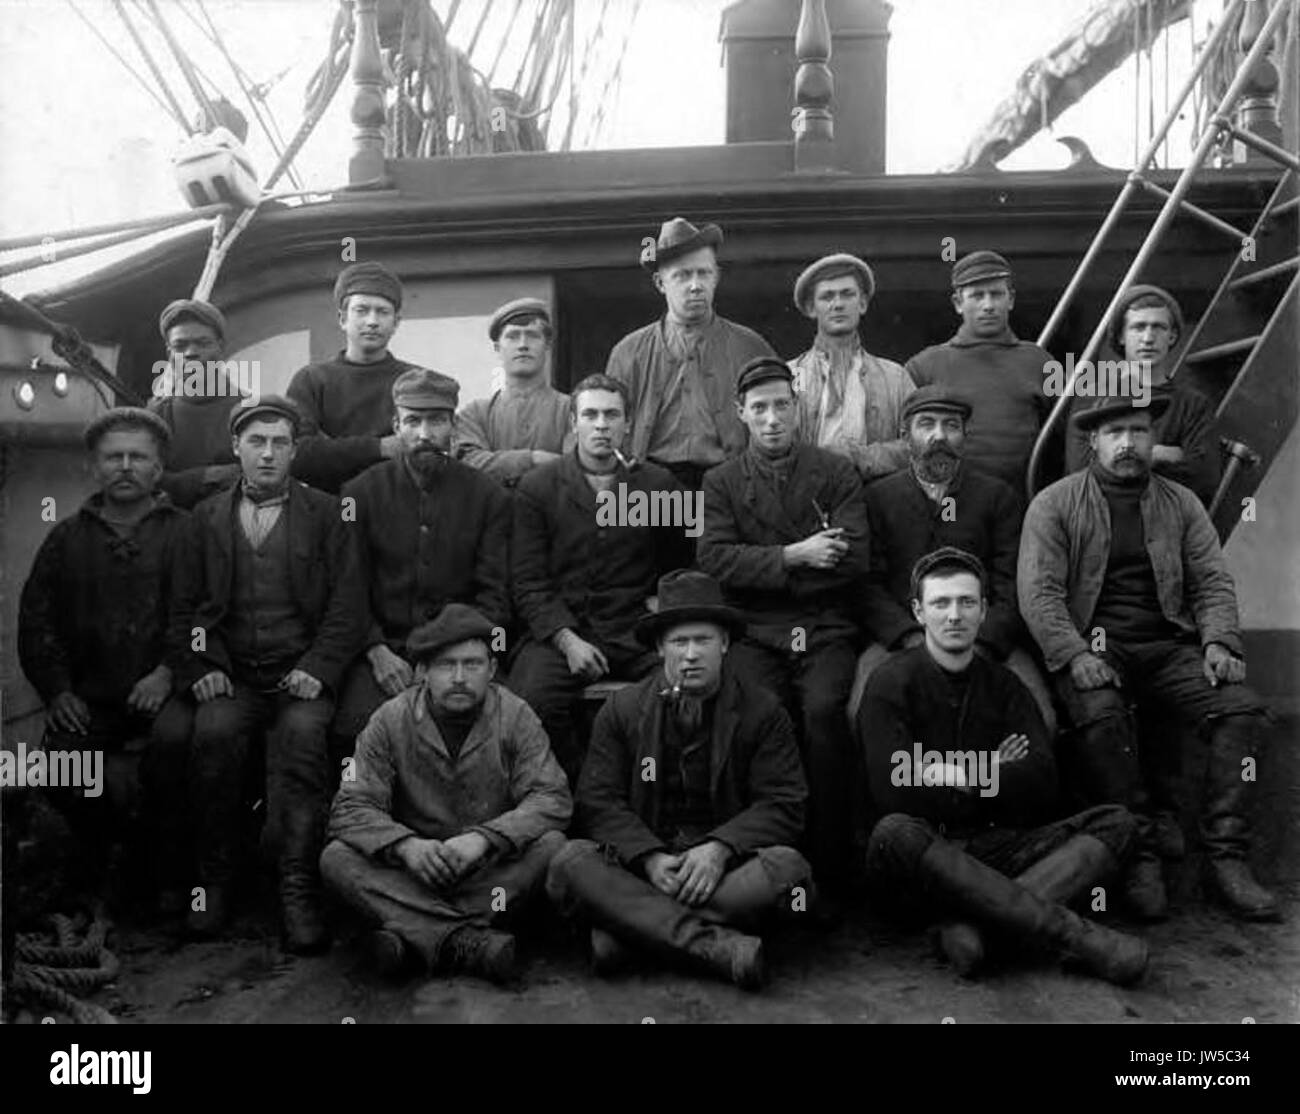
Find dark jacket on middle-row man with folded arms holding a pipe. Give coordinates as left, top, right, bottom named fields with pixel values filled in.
left=699, top=443, right=870, bottom=650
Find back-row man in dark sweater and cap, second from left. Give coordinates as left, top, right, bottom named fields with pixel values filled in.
left=287, top=263, right=415, bottom=493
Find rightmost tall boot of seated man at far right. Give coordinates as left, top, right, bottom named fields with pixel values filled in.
left=1201, top=715, right=1282, bottom=920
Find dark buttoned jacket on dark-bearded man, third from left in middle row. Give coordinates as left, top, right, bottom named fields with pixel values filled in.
left=342, top=456, right=510, bottom=654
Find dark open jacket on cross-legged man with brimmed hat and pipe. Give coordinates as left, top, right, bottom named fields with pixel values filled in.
left=577, top=668, right=807, bottom=866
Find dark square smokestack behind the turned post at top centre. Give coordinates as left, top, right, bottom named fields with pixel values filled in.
left=719, top=0, right=893, bottom=174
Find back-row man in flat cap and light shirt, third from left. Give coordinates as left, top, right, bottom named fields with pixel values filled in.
left=456, top=298, right=571, bottom=487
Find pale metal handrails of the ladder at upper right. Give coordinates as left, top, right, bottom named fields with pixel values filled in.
left=1026, top=0, right=1300, bottom=498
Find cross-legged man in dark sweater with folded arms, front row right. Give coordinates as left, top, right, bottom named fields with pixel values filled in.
left=858, top=547, right=1147, bottom=984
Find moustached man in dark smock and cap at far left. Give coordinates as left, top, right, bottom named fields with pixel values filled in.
left=18, top=407, right=190, bottom=913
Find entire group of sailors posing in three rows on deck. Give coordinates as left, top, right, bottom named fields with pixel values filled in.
left=18, top=217, right=1279, bottom=987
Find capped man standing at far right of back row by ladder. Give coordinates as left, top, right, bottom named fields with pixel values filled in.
left=1066, top=285, right=1219, bottom=507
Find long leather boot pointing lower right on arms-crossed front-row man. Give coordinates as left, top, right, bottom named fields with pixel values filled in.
left=918, top=840, right=1147, bottom=985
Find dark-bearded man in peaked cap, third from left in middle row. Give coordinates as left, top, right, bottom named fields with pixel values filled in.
left=334, top=368, right=510, bottom=754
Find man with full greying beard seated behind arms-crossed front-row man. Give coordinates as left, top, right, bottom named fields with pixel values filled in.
left=850, top=386, right=1056, bottom=738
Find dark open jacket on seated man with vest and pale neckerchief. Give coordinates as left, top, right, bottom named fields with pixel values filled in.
left=172, top=482, right=367, bottom=692
